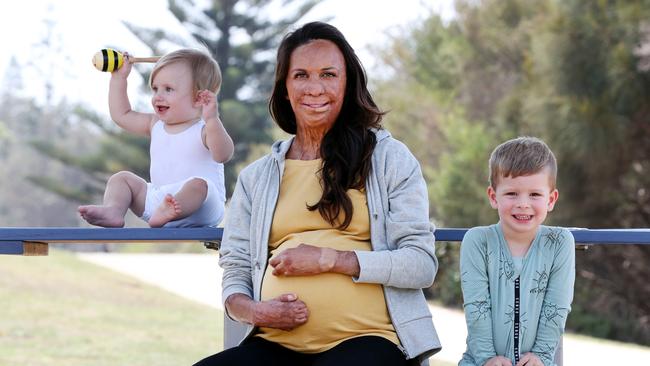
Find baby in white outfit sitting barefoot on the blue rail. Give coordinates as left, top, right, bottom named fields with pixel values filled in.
left=79, top=49, right=234, bottom=227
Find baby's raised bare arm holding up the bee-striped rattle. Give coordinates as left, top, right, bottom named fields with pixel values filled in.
left=108, top=52, right=155, bottom=136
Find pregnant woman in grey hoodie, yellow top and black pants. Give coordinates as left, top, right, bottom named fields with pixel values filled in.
left=196, top=22, right=440, bottom=366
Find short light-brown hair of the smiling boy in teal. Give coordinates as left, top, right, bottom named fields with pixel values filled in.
left=489, top=136, right=557, bottom=190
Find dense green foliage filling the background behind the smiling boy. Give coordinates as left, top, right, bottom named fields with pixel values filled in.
left=379, top=0, right=650, bottom=344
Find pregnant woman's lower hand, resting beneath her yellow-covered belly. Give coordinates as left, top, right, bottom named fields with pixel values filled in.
left=253, top=294, right=309, bottom=330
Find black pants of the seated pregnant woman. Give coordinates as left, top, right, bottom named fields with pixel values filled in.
left=194, top=336, right=412, bottom=366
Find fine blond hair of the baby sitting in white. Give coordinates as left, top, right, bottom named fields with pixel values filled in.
left=149, top=48, right=221, bottom=94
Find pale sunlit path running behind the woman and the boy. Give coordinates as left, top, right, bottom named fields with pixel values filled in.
left=79, top=253, right=650, bottom=366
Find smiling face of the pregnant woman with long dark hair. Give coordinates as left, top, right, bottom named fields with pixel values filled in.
left=286, top=39, right=347, bottom=131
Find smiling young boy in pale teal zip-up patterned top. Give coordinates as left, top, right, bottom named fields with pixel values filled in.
left=458, top=137, right=575, bottom=366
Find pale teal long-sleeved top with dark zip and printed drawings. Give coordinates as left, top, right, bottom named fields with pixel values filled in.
left=458, top=224, right=575, bottom=366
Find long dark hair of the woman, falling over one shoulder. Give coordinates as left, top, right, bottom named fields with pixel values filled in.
left=269, top=22, right=384, bottom=229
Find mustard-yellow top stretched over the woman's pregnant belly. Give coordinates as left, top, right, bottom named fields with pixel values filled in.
left=257, top=159, right=399, bottom=353
